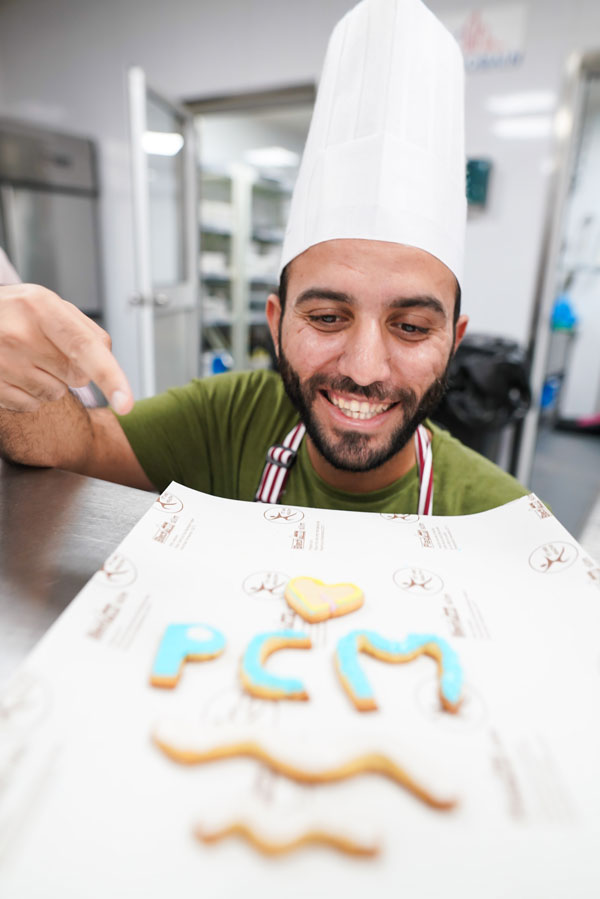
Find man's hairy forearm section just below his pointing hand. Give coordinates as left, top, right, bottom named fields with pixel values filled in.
left=0, top=392, right=94, bottom=471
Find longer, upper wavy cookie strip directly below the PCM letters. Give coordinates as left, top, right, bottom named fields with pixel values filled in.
left=152, top=724, right=456, bottom=811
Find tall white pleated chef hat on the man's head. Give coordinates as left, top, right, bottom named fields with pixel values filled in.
left=281, top=0, right=466, bottom=282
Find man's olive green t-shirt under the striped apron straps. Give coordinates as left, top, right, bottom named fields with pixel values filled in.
left=119, top=371, right=527, bottom=515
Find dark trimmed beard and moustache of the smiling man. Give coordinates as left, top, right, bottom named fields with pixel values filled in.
left=278, top=340, right=452, bottom=472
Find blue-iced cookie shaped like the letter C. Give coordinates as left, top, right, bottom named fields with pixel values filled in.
left=240, top=630, right=312, bottom=699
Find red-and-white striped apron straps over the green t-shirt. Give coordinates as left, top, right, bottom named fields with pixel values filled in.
left=254, top=422, right=433, bottom=515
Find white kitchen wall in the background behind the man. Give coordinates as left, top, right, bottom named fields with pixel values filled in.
left=0, top=0, right=600, bottom=389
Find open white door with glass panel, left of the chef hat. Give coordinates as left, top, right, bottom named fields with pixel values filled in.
left=129, top=68, right=200, bottom=396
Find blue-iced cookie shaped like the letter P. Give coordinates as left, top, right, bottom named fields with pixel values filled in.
left=150, top=624, right=225, bottom=687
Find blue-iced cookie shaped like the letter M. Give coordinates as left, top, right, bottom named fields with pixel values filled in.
left=335, top=631, right=463, bottom=712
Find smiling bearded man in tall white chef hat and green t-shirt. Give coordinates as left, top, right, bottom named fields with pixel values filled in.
left=0, top=0, right=525, bottom=514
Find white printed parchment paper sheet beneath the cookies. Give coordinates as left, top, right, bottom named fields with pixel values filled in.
left=0, top=483, right=600, bottom=899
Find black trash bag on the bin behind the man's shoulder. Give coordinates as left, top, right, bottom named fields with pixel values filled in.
left=433, top=334, right=531, bottom=458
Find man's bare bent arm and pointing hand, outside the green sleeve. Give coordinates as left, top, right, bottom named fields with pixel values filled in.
left=0, top=284, right=154, bottom=490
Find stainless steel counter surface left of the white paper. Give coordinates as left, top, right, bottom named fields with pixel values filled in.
left=0, top=460, right=155, bottom=683
